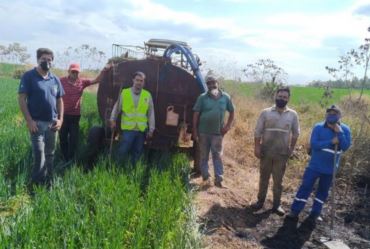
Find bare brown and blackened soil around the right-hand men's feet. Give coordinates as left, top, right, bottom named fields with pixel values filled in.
left=191, top=138, right=370, bottom=249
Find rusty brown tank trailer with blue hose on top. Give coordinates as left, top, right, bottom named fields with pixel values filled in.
left=88, top=39, right=207, bottom=167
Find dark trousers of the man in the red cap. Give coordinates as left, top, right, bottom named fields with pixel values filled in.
left=59, top=115, right=81, bottom=161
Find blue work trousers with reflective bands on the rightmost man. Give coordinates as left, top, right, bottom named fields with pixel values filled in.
left=291, top=168, right=333, bottom=216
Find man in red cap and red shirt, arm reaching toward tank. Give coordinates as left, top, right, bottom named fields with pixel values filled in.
left=59, top=63, right=105, bottom=161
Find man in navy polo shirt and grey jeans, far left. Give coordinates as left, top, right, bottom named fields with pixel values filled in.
left=18, top=48, right=64, bottom=184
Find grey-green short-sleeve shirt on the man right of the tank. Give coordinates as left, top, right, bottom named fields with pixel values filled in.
left=193, top=91, right=234, bottom=135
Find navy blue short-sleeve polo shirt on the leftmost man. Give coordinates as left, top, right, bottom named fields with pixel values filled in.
left=18, top=68, right=64, bottom=121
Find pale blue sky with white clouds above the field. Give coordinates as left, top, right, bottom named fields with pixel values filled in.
left=0, top=0, right=370, bottom=84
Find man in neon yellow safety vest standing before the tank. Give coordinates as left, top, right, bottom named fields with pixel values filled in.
left=110, top=71, right=155, bottom=165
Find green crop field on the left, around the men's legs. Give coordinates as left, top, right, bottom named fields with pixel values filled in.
left=0, top=65, right=199, bottom=249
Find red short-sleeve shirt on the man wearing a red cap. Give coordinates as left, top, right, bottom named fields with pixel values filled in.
left=60, top=77, right=91, bottom=116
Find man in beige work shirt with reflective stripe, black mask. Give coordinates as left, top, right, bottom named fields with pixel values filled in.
left=252, top=87, right=300, bottom=215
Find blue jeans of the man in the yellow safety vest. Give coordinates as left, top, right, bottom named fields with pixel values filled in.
left=117, top=130, right=145, bottom=165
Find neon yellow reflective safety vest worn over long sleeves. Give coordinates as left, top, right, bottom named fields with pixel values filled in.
left=121, top=88, right=150, bottom=131
